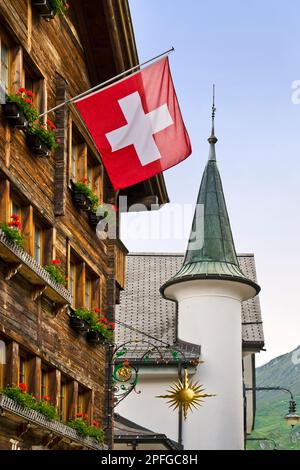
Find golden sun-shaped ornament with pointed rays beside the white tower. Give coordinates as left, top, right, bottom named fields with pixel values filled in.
left=156, top=369, right=216, bottom=419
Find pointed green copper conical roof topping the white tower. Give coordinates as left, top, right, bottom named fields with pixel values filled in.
left=161, top=111, right=260, bottom=293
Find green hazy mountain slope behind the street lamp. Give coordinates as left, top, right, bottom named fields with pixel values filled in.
left=247, top=346, right=300, bottom=450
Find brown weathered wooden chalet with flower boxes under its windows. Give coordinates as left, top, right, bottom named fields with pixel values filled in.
left=0, top=0, right=168, bottom=449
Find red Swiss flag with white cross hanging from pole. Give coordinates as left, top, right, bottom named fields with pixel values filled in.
left=76, top=58, right=192, bottom=190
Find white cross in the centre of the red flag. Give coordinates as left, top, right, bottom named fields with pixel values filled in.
left=106, top=91, right=173, bottom=166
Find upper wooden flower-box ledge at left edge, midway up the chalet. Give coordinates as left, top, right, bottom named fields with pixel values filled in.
left=0, top=230, right=71, bottom=306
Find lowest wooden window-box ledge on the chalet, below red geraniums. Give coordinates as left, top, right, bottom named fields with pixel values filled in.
left=0, top=394, right=106, bottom=450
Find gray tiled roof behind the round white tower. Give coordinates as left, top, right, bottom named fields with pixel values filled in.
left=116, top=253, right=264, bottom=356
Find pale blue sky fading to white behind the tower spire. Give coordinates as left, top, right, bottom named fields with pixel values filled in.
left=123, top=0, right=300, bottom=364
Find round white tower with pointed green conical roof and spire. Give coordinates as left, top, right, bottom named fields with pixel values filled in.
left=161, top=93, right=260, bottom=450
